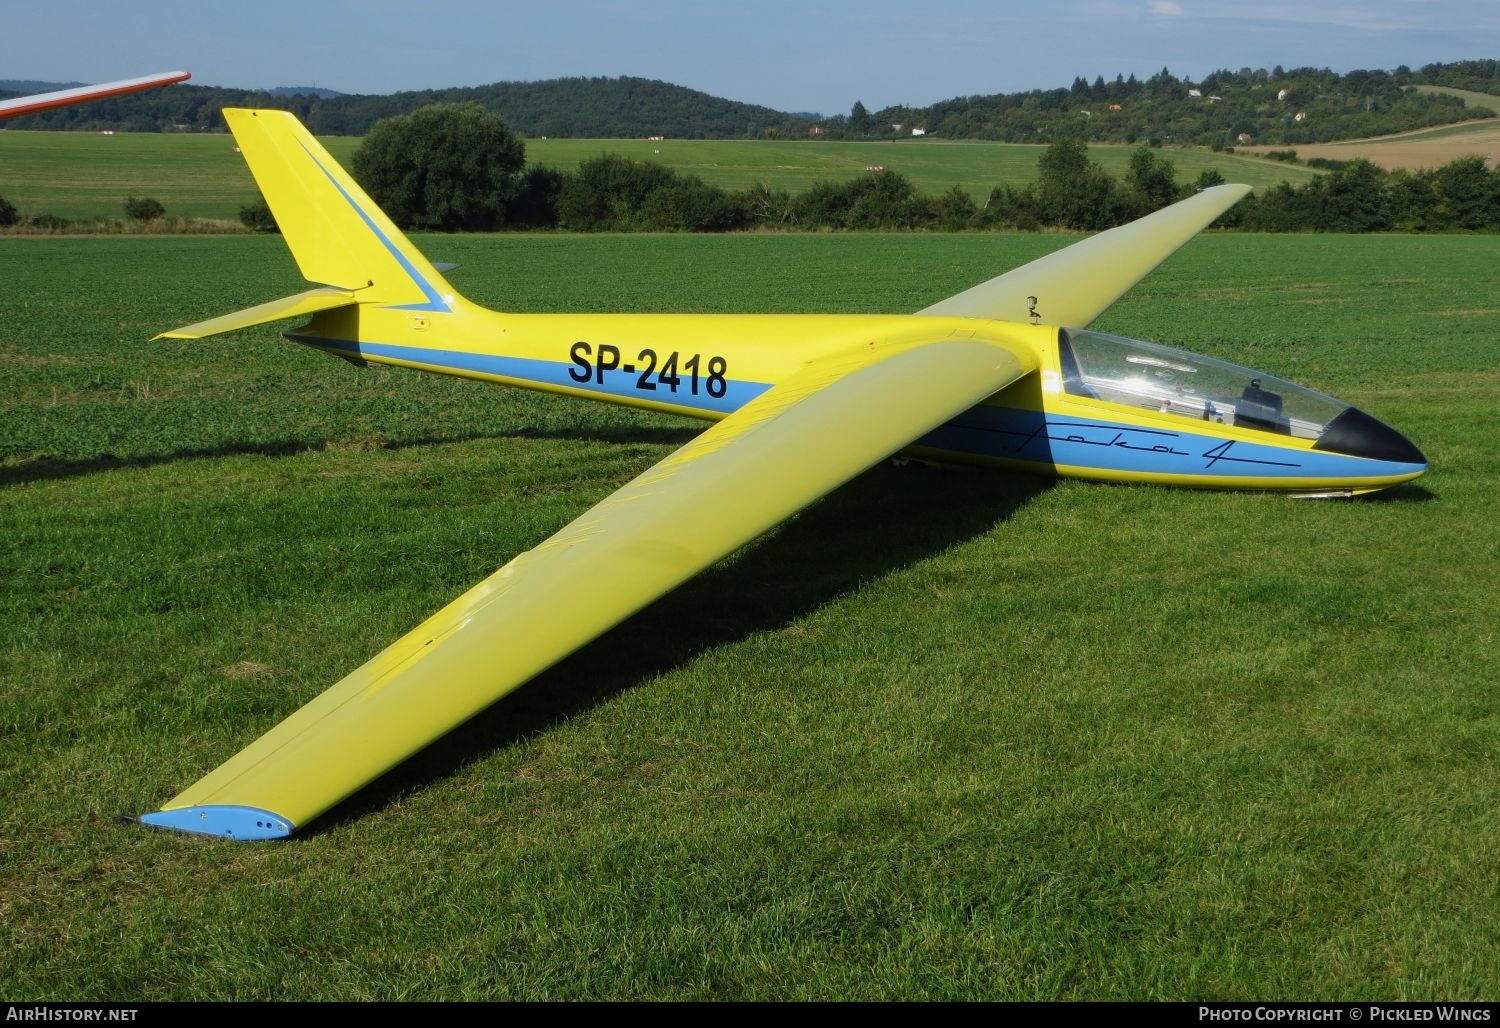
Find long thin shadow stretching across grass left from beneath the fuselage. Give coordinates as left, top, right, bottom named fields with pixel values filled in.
left=0, top=423, right=705, bottom=488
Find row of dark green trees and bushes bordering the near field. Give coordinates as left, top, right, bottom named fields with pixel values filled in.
left=325, top=104, right=1500, bottom=231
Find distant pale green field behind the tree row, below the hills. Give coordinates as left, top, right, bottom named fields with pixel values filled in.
left=0, top=132, right=1313, bottom=219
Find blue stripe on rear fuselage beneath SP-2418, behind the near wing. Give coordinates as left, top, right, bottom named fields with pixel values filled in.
left=285, top=332, right=771, bottom=414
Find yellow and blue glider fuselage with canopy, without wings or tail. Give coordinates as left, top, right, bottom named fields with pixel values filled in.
left=285, top=300, right=1427, bottom=495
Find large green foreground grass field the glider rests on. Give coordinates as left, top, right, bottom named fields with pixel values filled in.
left=0, top=228, right=1500, bottom=1001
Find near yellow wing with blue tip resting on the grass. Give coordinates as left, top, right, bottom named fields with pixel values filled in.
left=141, top=333, right=1035, bottom=839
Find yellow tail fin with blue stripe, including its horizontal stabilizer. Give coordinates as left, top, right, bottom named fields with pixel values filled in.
left=159, top=108, right=459, bottom=339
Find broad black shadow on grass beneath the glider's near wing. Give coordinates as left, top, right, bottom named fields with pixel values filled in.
left=312, top=462, right=1056, bottom=834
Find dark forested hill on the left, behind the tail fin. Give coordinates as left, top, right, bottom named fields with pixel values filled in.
left=0, top=78, right=809, bottom=140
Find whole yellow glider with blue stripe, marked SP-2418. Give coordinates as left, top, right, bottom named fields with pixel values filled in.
left=141, top=110, right=1425, bottom=839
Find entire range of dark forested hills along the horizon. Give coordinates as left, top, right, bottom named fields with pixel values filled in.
left=8, top=60, right=1500, bottom=147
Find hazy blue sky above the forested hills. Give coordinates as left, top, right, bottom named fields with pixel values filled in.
left=0, top=0, right=1500, bottom=114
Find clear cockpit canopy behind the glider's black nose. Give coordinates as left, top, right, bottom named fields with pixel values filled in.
left=1058, top=329, right=1349, bottom=440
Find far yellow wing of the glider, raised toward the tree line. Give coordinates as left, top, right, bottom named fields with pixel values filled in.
left=918, top=185, right=1250, bottom=329
